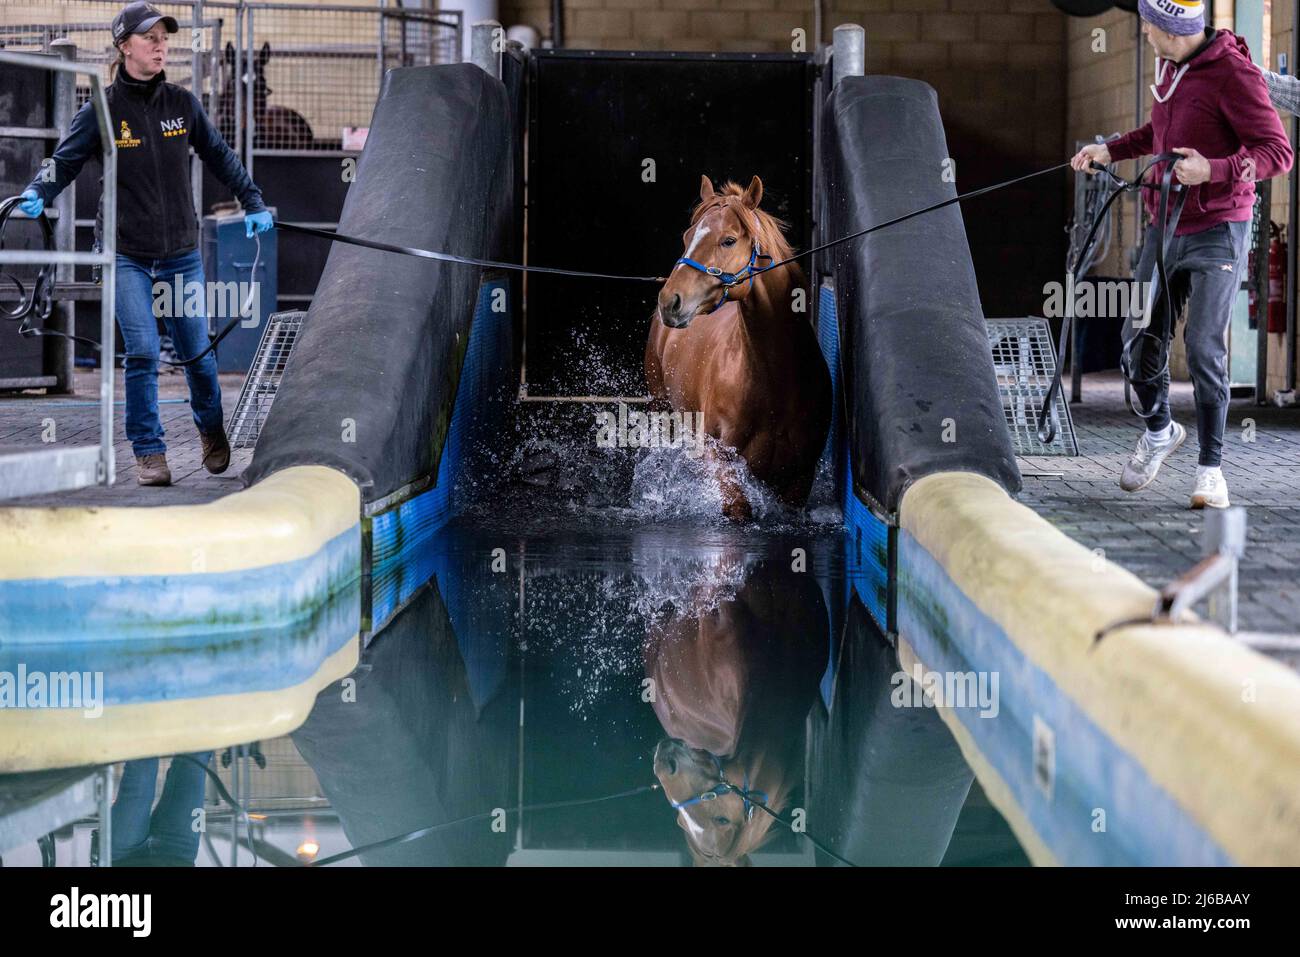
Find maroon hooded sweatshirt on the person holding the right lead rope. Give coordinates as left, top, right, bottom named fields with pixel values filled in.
left=1106, top=30, right=1292, bottom=235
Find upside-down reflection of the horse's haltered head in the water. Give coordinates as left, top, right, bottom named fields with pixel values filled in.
left=654, top=737, right=771, bottom=867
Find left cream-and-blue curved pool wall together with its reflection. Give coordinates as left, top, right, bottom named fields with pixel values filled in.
left=0, top=467, right=361, bottom=771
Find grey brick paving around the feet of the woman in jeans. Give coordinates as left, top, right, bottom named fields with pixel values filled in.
left=0, top=369, right=252, bottom=506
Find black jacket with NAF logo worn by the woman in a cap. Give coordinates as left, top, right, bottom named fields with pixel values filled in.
left=29, top=69, right=267, bottom=259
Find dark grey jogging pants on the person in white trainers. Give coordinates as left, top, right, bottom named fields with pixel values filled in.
left=1123, top=222, right=1251, bottom=465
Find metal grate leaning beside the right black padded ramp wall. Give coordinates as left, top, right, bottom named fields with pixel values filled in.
left=987, top=319, right=1079, bottom=455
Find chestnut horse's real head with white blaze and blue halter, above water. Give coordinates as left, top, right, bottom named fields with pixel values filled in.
left=659, top=176, right=775, bottom=329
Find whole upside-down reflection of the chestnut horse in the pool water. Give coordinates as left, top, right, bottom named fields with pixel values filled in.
left=646, top=546, right=827, bottom=866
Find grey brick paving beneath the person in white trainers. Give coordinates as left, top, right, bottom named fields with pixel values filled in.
left=1021, top=373, right=1300, bottom=635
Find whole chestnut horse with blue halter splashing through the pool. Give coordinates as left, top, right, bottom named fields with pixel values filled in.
left=646, top=176, right=831, bottom=521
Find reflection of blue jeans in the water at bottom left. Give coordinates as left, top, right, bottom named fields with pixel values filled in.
left=113, top=752, right=212, bottom=862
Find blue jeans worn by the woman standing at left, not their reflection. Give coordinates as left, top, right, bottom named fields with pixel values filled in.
left=116, top=250, right=222, bottom=455
